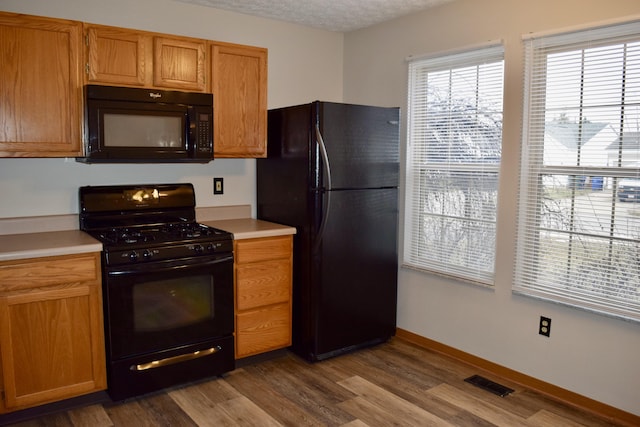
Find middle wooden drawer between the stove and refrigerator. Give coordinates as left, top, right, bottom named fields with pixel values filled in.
left=236, top=260, right=291, bottom=310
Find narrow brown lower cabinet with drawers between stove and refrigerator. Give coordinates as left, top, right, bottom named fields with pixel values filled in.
left=234, top=235, right=293, bottom=359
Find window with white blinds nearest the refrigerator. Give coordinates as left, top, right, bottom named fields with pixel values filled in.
left=404, top=44, right=504, bottom=285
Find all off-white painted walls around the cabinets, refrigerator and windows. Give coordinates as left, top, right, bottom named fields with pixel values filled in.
left=0, top=0, right=640, bottom=422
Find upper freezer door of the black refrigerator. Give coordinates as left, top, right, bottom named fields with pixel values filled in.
left=314, top=102, right=400, bottom=189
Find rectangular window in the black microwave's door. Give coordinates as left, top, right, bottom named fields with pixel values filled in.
left=103, top=113, right=184, bottom=148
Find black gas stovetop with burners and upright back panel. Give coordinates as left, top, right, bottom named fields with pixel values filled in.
left=79, top=184, right=233, bottom=265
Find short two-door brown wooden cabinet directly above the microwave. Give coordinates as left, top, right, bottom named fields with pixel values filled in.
left=85, top=24, right=207, bottom=92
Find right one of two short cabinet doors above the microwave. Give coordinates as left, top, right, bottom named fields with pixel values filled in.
left=153, top=37, right=206, bottom=92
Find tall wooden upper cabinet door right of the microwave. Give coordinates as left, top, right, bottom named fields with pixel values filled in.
left=211, top=44, right=267, bottom=157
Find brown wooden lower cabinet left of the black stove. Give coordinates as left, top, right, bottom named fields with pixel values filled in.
left=0, top=253, right=106, bottom=413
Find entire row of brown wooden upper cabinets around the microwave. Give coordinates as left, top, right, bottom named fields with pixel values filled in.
left=0, top=12, right=267, bottom=158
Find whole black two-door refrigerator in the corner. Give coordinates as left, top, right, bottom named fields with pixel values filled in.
left=256, top=101, right=400, bottom=362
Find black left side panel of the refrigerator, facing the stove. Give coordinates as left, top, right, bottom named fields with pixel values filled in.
left=256, top=104, right=323, bottom=357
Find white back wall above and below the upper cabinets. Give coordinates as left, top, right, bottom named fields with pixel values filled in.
left=0, top=0, right=343, bottom=218
